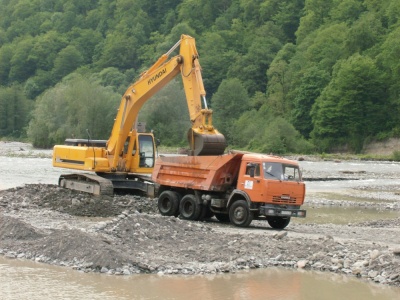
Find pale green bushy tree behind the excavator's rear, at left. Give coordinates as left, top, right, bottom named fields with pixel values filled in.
left=28, top=74, right=120, bottom=148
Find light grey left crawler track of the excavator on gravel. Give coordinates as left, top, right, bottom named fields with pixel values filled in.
left=58, top=173, right=114, bottom=196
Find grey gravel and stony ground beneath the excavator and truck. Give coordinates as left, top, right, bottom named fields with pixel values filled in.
left=0, top=142, right=400, bottom=286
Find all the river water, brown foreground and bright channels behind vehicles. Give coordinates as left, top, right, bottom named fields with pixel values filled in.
left=0, top=156, right=400, bottom=300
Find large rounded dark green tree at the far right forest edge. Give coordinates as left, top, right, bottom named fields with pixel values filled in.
left=311, top=54, right=392, bottom=152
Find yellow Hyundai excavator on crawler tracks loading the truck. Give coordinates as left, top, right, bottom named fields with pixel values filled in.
left=53, top=35, right=226, bottom=195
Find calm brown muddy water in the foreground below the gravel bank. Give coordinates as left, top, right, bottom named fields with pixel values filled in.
left=0, top=257, right=400, bottom=300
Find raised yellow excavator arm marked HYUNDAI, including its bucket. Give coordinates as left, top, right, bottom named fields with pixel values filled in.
left=107, top=35, right=226, bottom=168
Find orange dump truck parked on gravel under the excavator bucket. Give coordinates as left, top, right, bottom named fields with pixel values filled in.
left=152, top=152, right=306, bottom=229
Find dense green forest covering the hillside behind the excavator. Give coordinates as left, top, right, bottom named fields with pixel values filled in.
left=0, top=0, right=400, bottom=154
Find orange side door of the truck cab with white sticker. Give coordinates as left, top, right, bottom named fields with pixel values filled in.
left=240, top=162, right=264, bottom=201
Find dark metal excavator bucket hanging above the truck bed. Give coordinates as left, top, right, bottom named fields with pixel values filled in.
left=188, top=129, right=226, bottom=156
